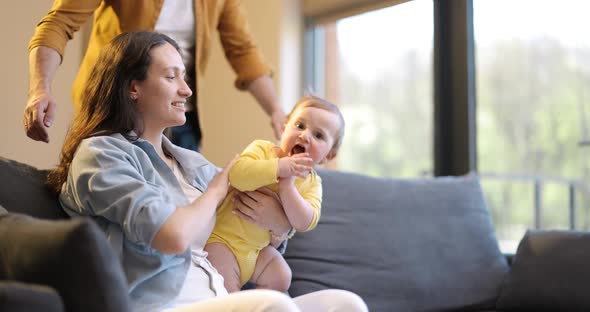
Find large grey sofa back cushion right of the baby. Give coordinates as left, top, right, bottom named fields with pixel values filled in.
left=285, top=170, right=508, bottom=311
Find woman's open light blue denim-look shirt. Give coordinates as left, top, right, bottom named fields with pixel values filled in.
left=59, top=134, right=219, bottom=311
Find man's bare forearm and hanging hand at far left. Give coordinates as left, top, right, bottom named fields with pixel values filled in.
left=23, top=46, right=61, bottom=143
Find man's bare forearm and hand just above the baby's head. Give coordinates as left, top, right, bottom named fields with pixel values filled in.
left=248, top=75, right=285, bottom=140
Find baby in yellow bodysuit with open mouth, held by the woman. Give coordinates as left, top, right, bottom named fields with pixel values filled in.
left=205, top=96, right=344, bottom=292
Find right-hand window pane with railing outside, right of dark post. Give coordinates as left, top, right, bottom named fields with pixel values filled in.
left=473, top=0, right=590, bottom=252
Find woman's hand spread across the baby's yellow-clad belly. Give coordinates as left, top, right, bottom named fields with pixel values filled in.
left=233, top=187, right=291, bottom=236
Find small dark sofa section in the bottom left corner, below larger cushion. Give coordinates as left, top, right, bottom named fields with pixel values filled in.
left=0, top=281, right=65, bottom=312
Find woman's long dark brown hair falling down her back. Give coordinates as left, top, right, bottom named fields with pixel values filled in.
left=47, top=31, right=180, bottom=192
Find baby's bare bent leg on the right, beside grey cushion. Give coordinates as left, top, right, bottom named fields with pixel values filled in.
left=250, top=246, right=291, bottom=292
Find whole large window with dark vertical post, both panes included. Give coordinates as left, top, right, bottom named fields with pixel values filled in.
left=306, top=0, right=590, bottom=252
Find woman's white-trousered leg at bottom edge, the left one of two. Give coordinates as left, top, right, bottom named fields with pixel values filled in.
left=166, top=289, right=300, bottom=312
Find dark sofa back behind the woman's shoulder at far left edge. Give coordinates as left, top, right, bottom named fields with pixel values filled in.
left=0, top=157, right=67, bottom=219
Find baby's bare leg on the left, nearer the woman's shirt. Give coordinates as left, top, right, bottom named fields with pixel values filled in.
left=205, top=243, right=240, bottom=293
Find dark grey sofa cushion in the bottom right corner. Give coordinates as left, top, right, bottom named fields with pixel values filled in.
left=497, top=230, right=590, bottom=312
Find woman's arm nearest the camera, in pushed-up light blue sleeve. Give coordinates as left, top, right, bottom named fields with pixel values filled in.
left=66, top=137, right=235, bottom=253
